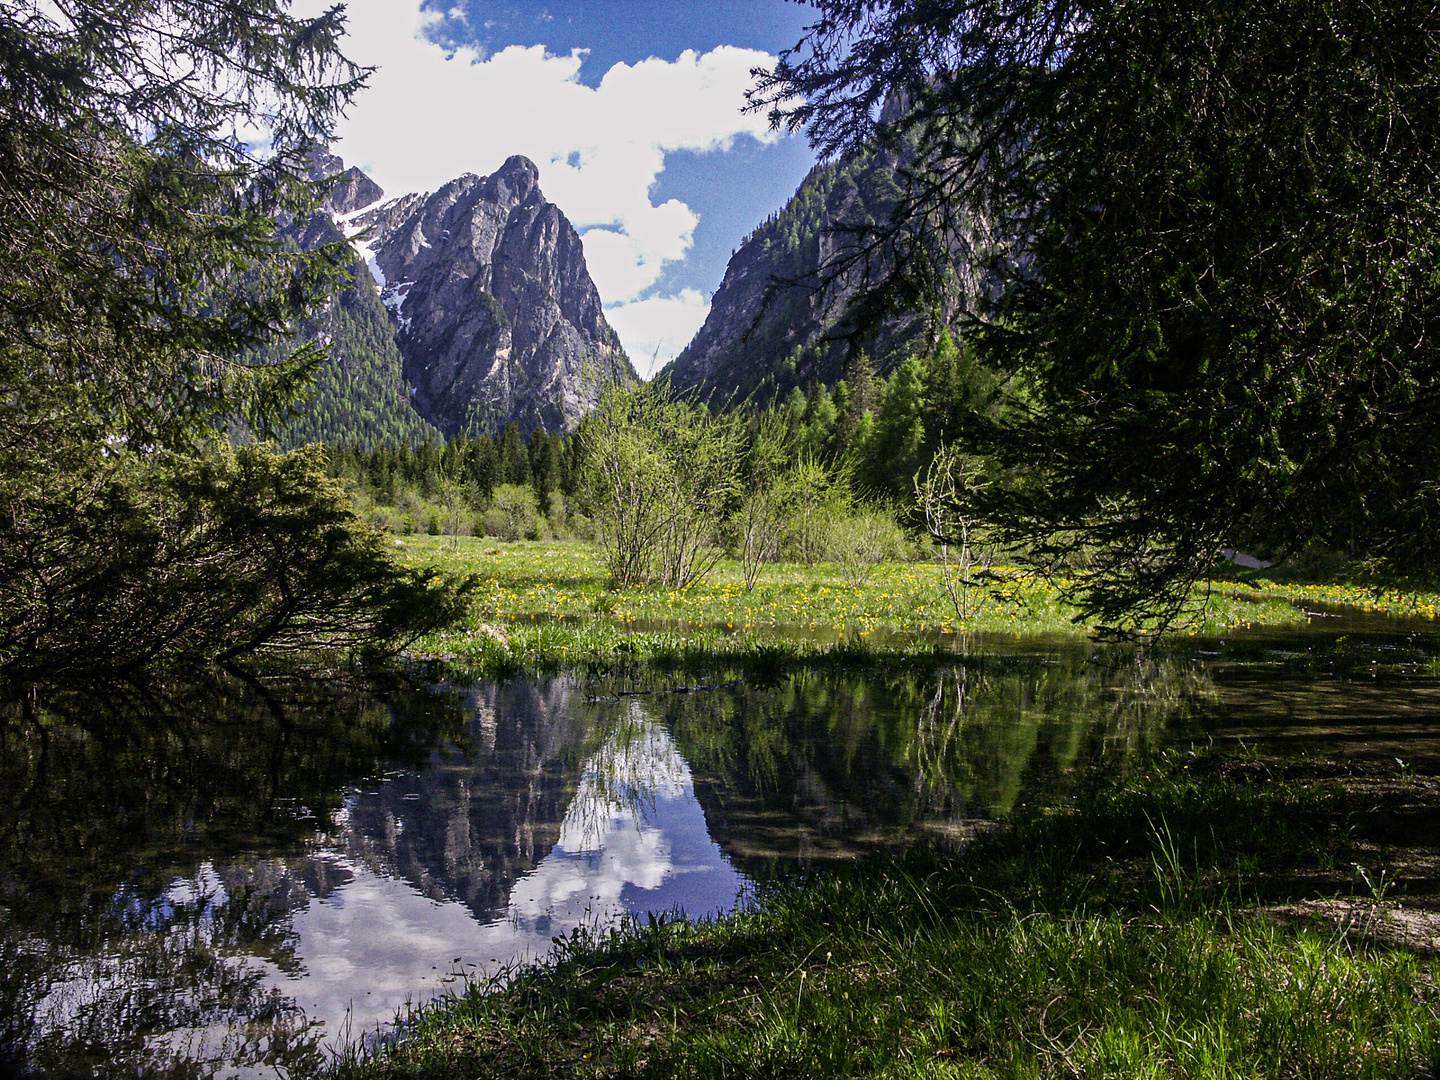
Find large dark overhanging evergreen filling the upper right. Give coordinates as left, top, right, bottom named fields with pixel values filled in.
left=752, top=0, right=1440, bottom=632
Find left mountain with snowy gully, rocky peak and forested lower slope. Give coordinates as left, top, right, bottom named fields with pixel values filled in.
left=268, top=150, right=636, bottom=448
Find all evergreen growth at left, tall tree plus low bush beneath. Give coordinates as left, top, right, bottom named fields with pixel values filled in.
left=0, top=0, right=464, bottom=680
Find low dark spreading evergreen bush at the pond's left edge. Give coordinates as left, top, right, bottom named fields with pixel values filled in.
left=0, top=445, right=469, bottom=680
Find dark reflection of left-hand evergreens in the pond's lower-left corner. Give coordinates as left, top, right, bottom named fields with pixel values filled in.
left=0, top=671, right=464, bottom=1076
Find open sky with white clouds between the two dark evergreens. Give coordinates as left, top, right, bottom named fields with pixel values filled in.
left=336, top=0, right=814, bottom=374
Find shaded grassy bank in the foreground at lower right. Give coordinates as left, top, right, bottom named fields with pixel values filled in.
left=318, top=755, right=1440, bottom=1079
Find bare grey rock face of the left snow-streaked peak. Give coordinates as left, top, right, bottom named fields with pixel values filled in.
left=330, top=157, right=635, bottom=435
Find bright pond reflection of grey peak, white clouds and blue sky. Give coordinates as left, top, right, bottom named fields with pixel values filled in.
left=260, top=702, right=743, bottom=1048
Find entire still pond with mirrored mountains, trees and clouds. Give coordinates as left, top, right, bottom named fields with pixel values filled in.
left=0, top=621, right=1440, bottom=1077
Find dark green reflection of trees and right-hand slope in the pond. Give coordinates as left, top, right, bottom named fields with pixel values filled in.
left=636, top=648, right=1211, bottom=878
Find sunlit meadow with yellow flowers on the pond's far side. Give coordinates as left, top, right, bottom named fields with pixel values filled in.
left=385, top=537, right=1359, bottom=668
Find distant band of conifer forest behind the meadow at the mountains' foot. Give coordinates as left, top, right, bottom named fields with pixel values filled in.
left=327, top=331, right=1009, bottom=561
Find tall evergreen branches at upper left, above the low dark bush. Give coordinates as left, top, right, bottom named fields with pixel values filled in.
left=0, top=0, right=363, bottom=452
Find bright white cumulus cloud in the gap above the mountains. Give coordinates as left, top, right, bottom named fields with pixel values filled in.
left=326, top=0, right=776, bottom=359
